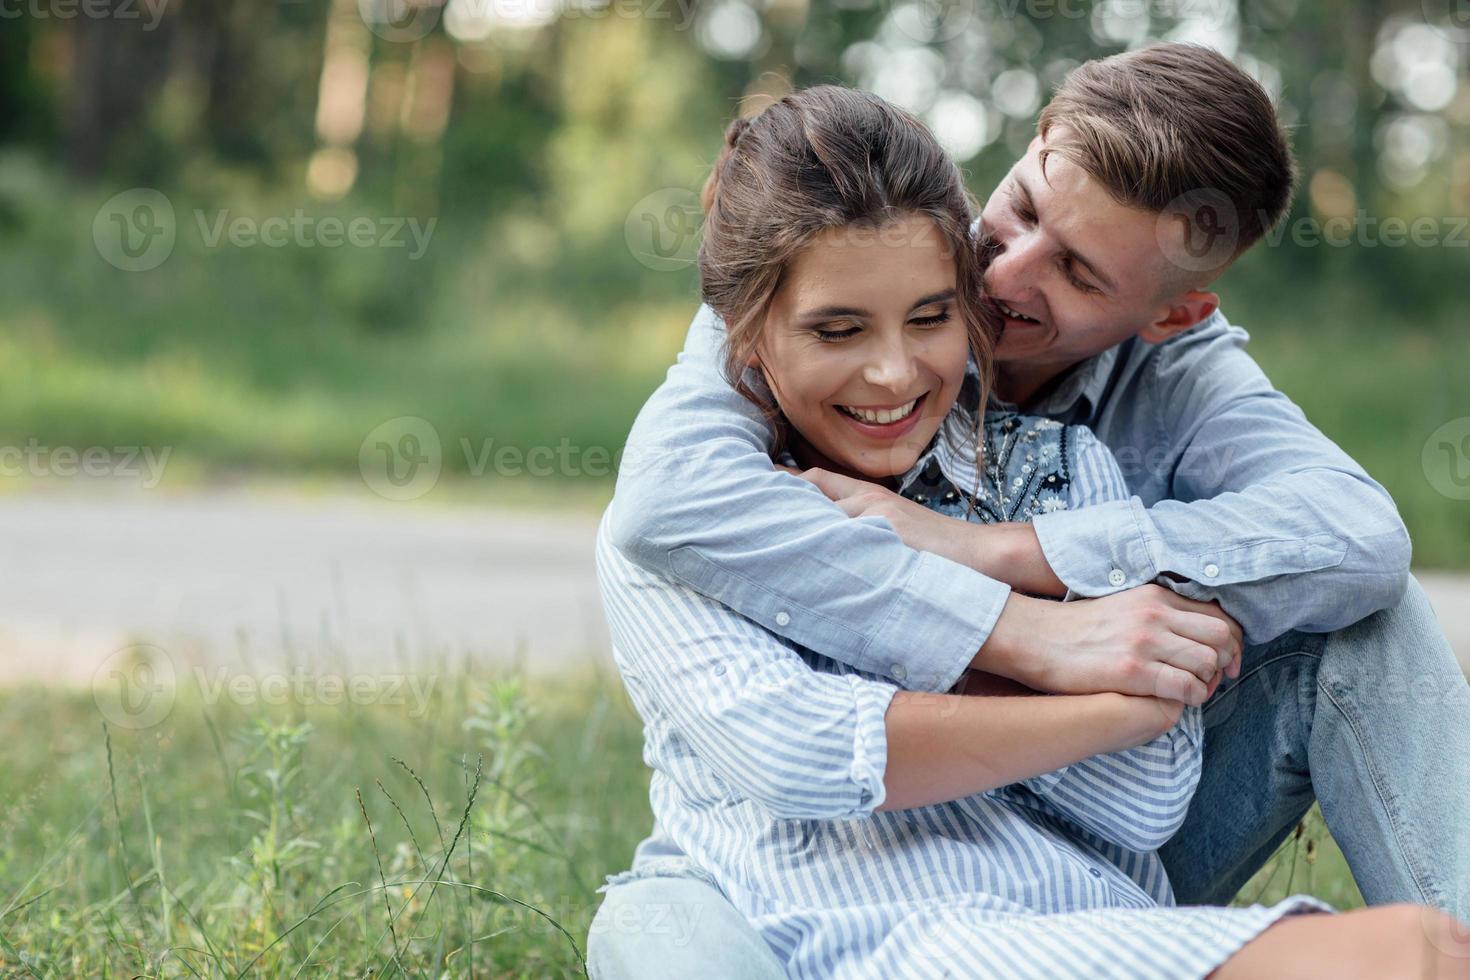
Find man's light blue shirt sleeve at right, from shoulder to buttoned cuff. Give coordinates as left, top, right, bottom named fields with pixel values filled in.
left=1033, top=314, right=1410, bottom=642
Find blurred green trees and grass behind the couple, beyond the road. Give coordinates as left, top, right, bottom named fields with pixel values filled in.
left=0, top=0, right=1470, bottom=567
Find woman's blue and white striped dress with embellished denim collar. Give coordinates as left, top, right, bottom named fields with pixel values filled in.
left=597, top=408, right=1326, bottom=977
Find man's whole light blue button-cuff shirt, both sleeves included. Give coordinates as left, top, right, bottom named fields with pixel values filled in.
left=609, top=307, right=1410, bottom=691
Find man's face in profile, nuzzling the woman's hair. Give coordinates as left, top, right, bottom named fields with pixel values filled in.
left=980, top=137, right=1214, bottom=398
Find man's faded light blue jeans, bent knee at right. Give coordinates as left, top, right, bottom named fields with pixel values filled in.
left=588, top=577, right=1470, bottom=980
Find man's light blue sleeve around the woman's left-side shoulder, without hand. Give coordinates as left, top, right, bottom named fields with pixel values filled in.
left=609, top=307, right=1010, bottom=691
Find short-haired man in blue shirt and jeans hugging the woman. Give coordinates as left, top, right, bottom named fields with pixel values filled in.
left=589, top=44, right=1470, bottom=977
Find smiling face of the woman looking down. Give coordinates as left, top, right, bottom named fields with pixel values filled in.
left=757, top=215, right=970, bottom=479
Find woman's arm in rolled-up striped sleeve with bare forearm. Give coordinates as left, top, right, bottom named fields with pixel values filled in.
left=597, top=520, right=1177, bottom=820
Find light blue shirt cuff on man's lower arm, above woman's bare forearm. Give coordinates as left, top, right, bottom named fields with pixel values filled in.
left=866, top=552, right=1010, bottom=693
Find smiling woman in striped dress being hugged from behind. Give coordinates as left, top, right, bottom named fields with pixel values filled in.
left=591, top=87, right=1470, bottom=977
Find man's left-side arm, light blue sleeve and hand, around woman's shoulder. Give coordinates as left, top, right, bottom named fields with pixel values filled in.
left=609, top=307, right=1228, bottom=704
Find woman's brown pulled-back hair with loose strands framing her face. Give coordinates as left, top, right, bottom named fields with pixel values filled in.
left=700, top=85, right=995, bottom=439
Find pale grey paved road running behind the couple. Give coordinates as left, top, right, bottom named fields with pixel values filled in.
left=0, top=492, right=1470, bottom=683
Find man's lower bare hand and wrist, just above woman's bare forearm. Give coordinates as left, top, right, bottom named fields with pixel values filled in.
left=972, top=585, right=1244, bottom=704
